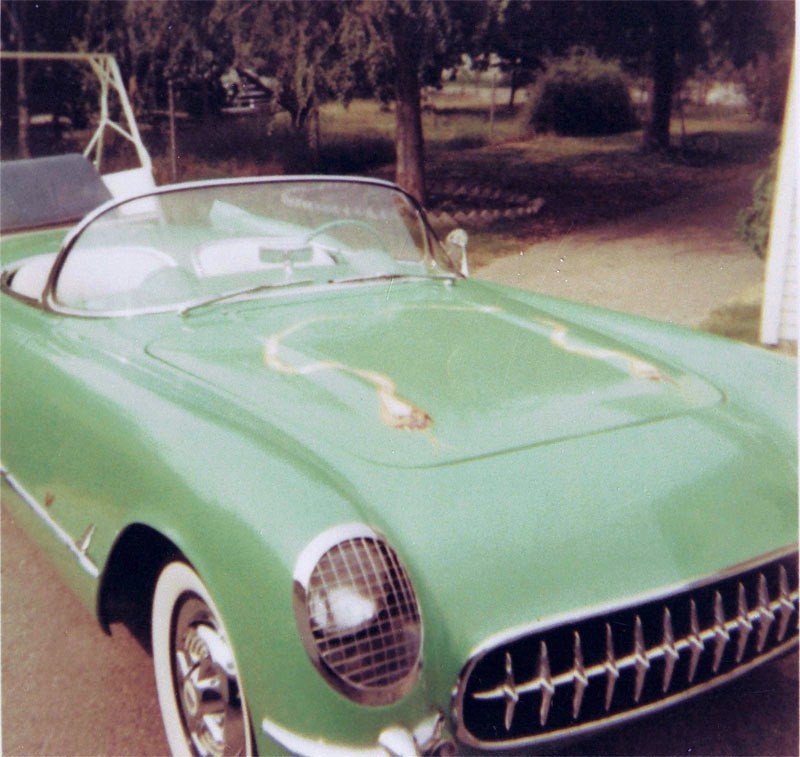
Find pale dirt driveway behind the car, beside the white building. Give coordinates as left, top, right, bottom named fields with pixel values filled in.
left=475, top=166, right=764, bottom=326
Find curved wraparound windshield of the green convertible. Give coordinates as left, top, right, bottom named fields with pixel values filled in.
left=54, top=179, right=455, bottom=314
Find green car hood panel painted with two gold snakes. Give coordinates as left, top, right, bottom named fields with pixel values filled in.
left=147, top=282, right=721, bottom=467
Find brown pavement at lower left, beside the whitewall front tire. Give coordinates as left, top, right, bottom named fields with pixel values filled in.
left=0, top=504, right=168, bottom=757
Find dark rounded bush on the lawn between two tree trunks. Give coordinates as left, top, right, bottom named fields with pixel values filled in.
left=530, top=49, right=638, bottom=136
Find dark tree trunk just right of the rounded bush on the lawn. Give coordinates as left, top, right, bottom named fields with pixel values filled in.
left=644, top=1, right=677, bottom=150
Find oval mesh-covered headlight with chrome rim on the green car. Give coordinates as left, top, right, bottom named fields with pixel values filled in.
left=294, top=524, right=422, bottom=705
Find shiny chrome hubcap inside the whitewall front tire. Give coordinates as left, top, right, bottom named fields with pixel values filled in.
left=173, top=594, right=247, bottom=757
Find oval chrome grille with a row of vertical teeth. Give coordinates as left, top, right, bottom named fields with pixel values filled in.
left=454, top=551, right=798, bottom=748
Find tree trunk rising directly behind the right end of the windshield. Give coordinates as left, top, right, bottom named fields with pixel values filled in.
left=394, top=17, right=427, bottom=204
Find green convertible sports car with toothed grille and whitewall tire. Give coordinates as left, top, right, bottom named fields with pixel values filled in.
left=0, top=156, right=798, bottom=755
